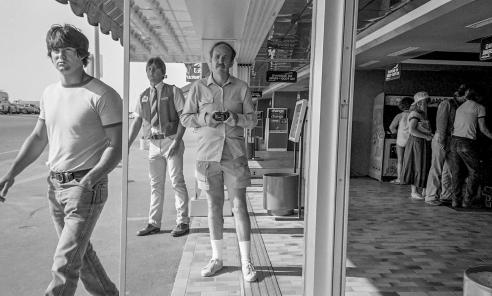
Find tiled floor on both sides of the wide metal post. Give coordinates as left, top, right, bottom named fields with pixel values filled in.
left=173, top=178, right=492, bottom=296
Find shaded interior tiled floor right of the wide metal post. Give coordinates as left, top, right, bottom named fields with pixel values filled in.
left=346, top=179, right=492, bottom=296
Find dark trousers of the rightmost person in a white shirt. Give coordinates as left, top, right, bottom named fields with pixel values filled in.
left=446, top=136, right=480, bottom=203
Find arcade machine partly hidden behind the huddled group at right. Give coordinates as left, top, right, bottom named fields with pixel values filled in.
left=369, top=93, right=451, bottom=181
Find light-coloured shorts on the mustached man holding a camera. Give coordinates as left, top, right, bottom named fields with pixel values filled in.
left=195, top=156, right=251, bottom=190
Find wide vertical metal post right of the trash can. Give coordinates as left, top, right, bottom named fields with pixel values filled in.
left=303, top=0, right=357, bottom=296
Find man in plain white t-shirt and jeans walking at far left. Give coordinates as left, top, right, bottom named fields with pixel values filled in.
left=0, top=25, right=122, bottom=296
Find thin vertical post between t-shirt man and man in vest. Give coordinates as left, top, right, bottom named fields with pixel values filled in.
left=119, top=0, right=130, bottom=295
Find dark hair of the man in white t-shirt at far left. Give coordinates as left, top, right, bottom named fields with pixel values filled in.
left=46, top=24, right=89, bottom=66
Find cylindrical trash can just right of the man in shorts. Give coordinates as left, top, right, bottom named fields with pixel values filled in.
left=263, top=173, right=299, bottom=216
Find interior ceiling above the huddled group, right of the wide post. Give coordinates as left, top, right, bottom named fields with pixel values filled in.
left=356, top=0, right=492, bottom=69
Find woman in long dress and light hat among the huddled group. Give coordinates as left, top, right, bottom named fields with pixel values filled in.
left=400, top=91, right=433, bottom=200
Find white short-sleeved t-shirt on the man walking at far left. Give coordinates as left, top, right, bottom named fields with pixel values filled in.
left=39, top=78, right=123, bottom=172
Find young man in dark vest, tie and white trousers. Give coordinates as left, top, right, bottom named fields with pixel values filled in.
left=129, top=57, right=190, bottom=236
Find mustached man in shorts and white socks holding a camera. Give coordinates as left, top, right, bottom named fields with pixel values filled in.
left=180, top=42, right=256, bottom=282
